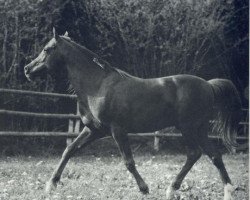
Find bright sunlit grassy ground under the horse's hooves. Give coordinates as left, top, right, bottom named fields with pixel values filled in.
left=0, top=139, right=249, bottom=200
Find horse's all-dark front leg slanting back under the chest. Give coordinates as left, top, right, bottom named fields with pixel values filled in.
left=112, top=127, right=149, bottom=194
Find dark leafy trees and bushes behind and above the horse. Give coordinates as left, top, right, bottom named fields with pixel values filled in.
left=0, top=0, right=248, bottom=85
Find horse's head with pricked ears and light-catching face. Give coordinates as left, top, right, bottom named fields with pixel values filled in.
left=24, top=28, right=68, bottom=81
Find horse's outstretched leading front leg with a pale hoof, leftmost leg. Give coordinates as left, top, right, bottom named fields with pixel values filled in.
left=45, top=126, right=101, bottom=193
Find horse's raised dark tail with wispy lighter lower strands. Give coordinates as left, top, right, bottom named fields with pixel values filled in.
left=208, top=79, right=245, bottom=150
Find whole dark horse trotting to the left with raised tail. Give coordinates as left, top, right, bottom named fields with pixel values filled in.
left=24, top=29, right=241, bottom=200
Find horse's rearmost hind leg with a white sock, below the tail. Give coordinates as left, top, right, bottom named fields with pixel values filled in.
left=200, top=133, right=234, bottom=200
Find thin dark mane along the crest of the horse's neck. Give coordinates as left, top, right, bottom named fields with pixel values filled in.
left=60, top=36, right=133, bottom=77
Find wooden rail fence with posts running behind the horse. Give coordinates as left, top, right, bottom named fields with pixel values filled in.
left=0, top=88, right=249, bottom=151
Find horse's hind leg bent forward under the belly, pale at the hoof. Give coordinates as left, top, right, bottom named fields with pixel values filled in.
left=166, top=131, right=202, bottom=200
